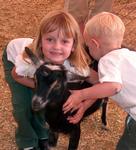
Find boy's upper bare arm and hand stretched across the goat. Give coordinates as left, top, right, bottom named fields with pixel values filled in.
left=63, top=82, right=122, bottom=113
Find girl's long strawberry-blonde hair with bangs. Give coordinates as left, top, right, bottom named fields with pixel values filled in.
left=26, top=11, right=89, bottom=70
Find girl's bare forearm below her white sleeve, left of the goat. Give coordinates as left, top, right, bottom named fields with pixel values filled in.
left=11, top=67, right=35, bottom=88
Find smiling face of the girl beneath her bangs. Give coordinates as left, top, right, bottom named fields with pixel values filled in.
left=42, top=30, right=74, bottom=64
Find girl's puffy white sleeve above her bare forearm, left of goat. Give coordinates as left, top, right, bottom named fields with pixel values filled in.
left=15, top=54, right=36, bottom=78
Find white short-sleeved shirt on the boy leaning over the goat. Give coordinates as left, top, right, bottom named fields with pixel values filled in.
left=98, top=48, right=136, bottom=120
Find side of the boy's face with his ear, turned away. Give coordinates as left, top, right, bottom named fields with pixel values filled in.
left=84, top=33, right=101, bottom=60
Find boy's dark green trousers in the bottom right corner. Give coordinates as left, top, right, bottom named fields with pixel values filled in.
left=116, top=116, right=136, bottom=150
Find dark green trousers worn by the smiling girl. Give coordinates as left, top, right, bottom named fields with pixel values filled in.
left=2, top=49, right=48, bottom=148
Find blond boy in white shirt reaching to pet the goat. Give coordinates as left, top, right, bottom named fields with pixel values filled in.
left=63, top=12, right=136, bottom=150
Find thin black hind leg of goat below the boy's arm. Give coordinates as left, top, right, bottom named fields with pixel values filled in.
left=101, top=97, right=108, bottom=128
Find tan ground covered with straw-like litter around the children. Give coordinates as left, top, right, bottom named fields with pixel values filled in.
left=0, top=0, right=136, bottom=150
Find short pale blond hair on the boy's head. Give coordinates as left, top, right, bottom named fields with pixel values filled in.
left=84, top=12, right=125, bottom=43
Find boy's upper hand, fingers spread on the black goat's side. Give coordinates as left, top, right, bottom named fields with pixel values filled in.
left=63, top=90, right=82, bottom=114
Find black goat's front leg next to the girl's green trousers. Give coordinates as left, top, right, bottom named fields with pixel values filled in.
left=48, top=129, right=59, bottom=147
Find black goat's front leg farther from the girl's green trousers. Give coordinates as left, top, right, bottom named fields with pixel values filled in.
left=68, top=124, right=81, bottom=150
